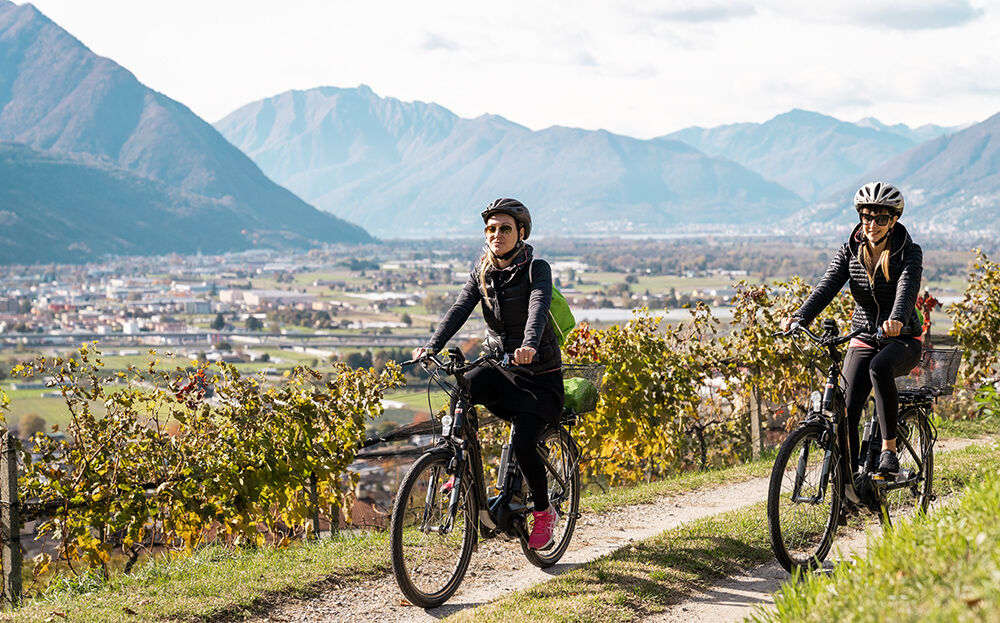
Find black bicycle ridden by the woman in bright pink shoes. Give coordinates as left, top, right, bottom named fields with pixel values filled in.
left=389, top=349, right=592, bottom=608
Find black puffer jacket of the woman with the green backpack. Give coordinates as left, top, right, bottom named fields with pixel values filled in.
left=426, top=244, right=562, bottom=372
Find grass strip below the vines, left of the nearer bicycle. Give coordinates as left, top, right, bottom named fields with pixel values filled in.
left=0, top=534, right=389, bottom=623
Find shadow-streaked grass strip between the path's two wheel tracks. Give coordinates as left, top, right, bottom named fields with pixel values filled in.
left=447, top=441, right=1000, bottom=623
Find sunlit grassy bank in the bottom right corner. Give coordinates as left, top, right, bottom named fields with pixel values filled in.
left=753, top=441, right=1000, bottom=623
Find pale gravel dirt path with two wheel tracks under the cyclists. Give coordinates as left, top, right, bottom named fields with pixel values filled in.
left=251, top=439, right=976, bottom=623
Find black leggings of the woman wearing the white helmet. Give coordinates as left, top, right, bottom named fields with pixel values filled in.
left=843, top=338, right=921, bottom=473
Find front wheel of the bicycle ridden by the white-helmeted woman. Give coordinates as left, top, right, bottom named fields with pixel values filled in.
left=767, top=423, right=844, bottom=572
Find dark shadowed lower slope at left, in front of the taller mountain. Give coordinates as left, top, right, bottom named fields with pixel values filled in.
left=0, top=143, right=286, bottom=264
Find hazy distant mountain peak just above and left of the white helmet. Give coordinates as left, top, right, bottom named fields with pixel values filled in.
left=663, top=110, right=917, bottom=200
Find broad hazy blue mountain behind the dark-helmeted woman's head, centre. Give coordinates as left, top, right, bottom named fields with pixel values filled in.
left=216, top=86, right=803, bottom=236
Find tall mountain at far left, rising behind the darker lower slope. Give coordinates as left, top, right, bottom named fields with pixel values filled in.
left=0, top=0, right=369, bottom=261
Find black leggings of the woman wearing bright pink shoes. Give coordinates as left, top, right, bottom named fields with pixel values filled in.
left=466, top=367, right=562, bottom=511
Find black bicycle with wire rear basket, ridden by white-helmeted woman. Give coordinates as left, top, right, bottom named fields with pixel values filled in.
left=767, top=320, right=961, bottom=572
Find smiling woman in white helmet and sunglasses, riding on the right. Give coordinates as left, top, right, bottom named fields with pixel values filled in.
left=783, top=182, right=923, bottom=474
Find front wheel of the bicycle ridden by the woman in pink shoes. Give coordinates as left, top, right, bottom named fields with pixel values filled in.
left=389, top=452, right=477, bottom=608
